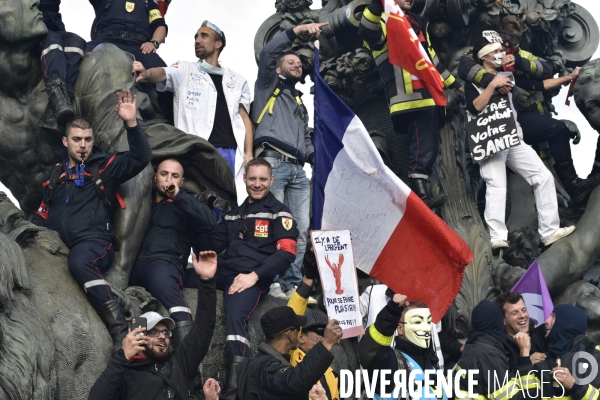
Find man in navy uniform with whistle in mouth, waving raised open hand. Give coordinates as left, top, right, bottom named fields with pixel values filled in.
left=32, top=90, right=152, bottom=349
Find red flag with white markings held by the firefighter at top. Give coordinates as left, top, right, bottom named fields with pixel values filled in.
left=382, top=0, right=446, bottom=106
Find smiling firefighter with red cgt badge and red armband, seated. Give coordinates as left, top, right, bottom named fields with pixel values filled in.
left=201, top=158, right=298, bottom=391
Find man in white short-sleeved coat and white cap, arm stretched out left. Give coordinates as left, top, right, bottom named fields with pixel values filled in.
left=133, top=21, right=253, bottom=204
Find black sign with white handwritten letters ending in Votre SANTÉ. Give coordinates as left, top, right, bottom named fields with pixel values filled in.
left=465, top=94, right=521, bottom=162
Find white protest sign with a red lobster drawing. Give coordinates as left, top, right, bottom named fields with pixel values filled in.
left=311, top=230, right=365, bottom=339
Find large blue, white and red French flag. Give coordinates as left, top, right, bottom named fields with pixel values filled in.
left=312, top=42, right=473, bottom=322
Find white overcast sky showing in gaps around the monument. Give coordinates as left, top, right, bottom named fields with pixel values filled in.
left=0, top=0, right=600, bottom=203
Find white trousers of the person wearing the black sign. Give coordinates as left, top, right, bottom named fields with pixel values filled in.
left=479, top=141, right=560, bottom=242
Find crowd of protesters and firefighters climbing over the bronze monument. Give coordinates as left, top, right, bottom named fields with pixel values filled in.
left=27, top=0, right=600, bottom=400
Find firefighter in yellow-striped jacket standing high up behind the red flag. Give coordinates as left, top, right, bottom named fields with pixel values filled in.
left=358, top=0, right=464, bottom=209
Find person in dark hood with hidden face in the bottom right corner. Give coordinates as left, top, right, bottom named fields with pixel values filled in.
left=536, top=304, right=600, bottom=400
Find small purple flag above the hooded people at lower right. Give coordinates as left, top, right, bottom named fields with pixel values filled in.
left=511, top=260, right=554, bottom=327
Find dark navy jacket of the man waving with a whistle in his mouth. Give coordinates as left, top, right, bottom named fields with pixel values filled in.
left=31, top=123, right=152, bottom=248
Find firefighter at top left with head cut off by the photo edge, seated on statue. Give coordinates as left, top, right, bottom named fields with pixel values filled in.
left=87, top=0, right=167, bottom=68
